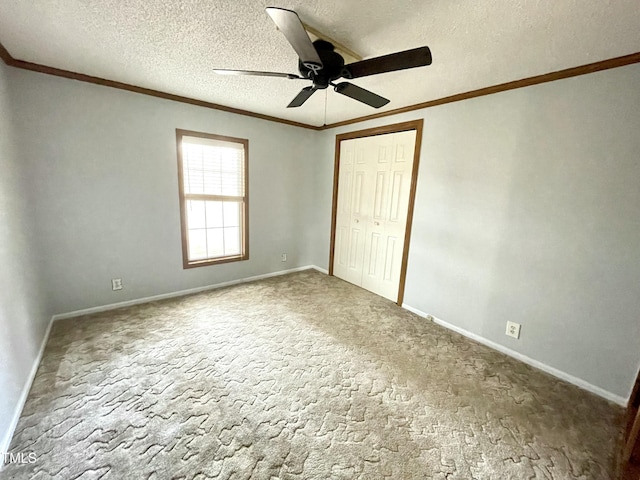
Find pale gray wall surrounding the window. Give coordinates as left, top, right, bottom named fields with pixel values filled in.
left=11, top=69, right=318, bottom=313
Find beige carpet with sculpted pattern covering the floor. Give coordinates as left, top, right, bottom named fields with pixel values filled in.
left=1, top=271, right=622, bottom=480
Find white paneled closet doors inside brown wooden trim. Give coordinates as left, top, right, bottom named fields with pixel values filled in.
left=333, top=130, right=416, bottom=301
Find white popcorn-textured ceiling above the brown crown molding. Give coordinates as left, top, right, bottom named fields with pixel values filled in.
left=0, top=0, right=640, bottom=125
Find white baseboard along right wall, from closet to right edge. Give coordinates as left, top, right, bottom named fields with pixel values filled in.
left=402, top=304, right=627, bottom=407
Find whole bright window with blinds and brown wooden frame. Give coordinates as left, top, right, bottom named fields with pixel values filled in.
left=176, top=130, right=249, bottom=268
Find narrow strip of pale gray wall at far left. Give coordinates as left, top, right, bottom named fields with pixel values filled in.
left=0, top=62, right=51, bottom=453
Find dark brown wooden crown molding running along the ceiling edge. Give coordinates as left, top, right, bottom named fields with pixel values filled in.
left=0, top=39, right=640, bottom=131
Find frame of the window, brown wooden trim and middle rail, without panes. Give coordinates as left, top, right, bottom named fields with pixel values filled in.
left=176, top=128, right=249, bottom=269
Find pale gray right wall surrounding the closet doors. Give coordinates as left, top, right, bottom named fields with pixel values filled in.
left=315, top=65, right=640, bottom=398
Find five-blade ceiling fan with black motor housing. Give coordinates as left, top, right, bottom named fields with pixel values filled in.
left=214, top=7, right=431, bottom=108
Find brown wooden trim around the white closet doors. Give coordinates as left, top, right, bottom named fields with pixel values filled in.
left=329, top=118, right=424, bottom=306
